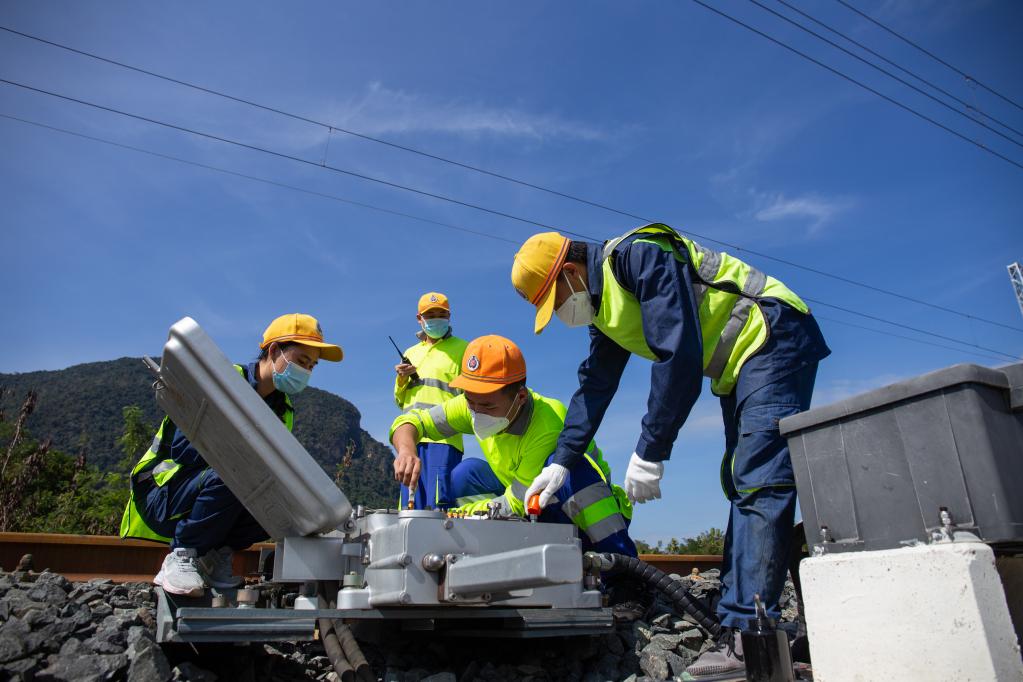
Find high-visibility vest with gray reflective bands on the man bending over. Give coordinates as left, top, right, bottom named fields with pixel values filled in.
left=593, top=223, right=809, bottom=396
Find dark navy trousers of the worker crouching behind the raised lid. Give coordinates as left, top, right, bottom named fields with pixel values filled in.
left=145, top=467, right=267, bottom=556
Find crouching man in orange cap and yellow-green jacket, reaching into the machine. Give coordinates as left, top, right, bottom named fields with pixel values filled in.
left=391, top=335, right=636, bottom=556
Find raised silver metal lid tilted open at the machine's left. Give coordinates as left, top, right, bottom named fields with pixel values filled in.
left=157, top=317, right=352, bottom=540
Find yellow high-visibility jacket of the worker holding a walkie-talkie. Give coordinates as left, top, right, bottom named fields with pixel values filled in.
left=394, top=334, right=469, bottom=451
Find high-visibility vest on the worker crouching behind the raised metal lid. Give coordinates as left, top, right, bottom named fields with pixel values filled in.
left=121, top=365, right=295, bottom=543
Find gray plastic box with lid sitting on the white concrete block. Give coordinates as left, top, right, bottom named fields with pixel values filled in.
left=780, top=363, right=1023, bottom=552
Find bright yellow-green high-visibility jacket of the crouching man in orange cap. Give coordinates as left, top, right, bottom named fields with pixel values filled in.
left=389, top=391, right=632, bottom=542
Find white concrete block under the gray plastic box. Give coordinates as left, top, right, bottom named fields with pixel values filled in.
left=800, top=542, right=1023, bottom=682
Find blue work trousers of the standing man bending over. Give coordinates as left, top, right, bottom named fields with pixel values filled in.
left=717, top=363, right=817, bottom=628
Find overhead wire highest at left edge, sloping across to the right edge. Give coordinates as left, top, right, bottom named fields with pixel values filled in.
left=0, top=26, right=1023, bottom=332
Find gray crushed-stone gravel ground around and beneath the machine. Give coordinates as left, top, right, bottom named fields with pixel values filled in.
left=0, top=571, right=796, bottom=682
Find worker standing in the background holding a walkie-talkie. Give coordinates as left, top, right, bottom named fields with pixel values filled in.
left=392, top=291, right=466, bottom=509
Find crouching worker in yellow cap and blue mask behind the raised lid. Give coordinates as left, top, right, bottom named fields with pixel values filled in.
left=121, top=313, right=342, bottom=595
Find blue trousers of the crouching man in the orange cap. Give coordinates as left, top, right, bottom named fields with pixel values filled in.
left=451, top=455, right=637, bottom=556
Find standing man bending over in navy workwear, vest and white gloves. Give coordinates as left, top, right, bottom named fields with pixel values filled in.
left=512, top=223, right=831, bottom=676
